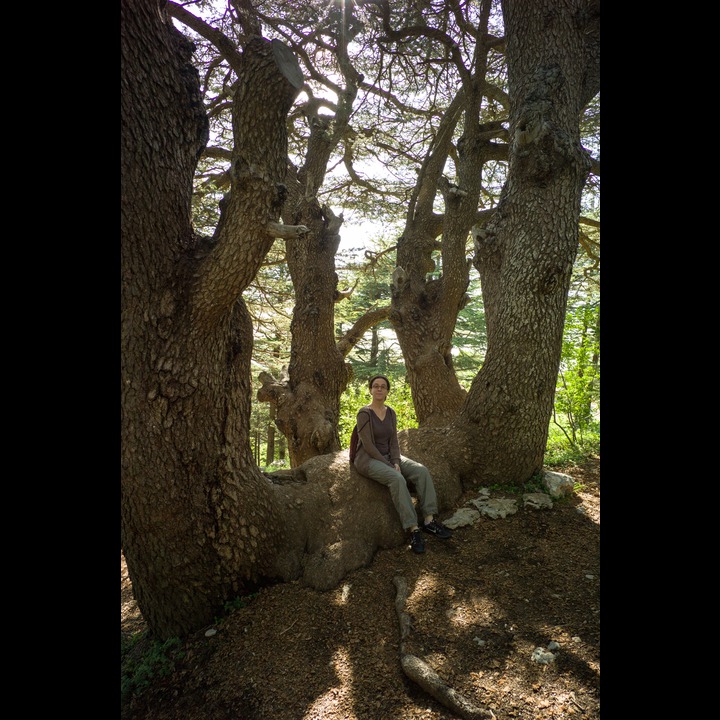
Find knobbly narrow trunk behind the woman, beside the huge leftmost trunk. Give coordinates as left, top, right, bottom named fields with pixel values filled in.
left=257, top=25, right=361, bottom=467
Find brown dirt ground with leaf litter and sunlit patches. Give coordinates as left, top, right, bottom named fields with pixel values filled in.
left=120, top=458, right=600, bottom=720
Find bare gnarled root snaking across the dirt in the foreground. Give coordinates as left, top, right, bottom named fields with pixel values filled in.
left=393, top=576, right=495, bottom=720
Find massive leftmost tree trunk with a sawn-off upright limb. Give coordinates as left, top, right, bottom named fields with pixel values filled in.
left=121, top=0, right=301, bottom=637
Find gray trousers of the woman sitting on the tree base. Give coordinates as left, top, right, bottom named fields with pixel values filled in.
left=367, top=455, right=437, bottom=530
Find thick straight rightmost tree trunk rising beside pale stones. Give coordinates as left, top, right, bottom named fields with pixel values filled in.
left=460, top=0, right=599, bottom=484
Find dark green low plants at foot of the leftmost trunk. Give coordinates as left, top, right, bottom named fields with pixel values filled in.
left=120, top=633, right=184, bottom=702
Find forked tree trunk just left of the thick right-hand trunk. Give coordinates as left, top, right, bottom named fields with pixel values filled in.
left=390, top=2, right=507, bottom=427
